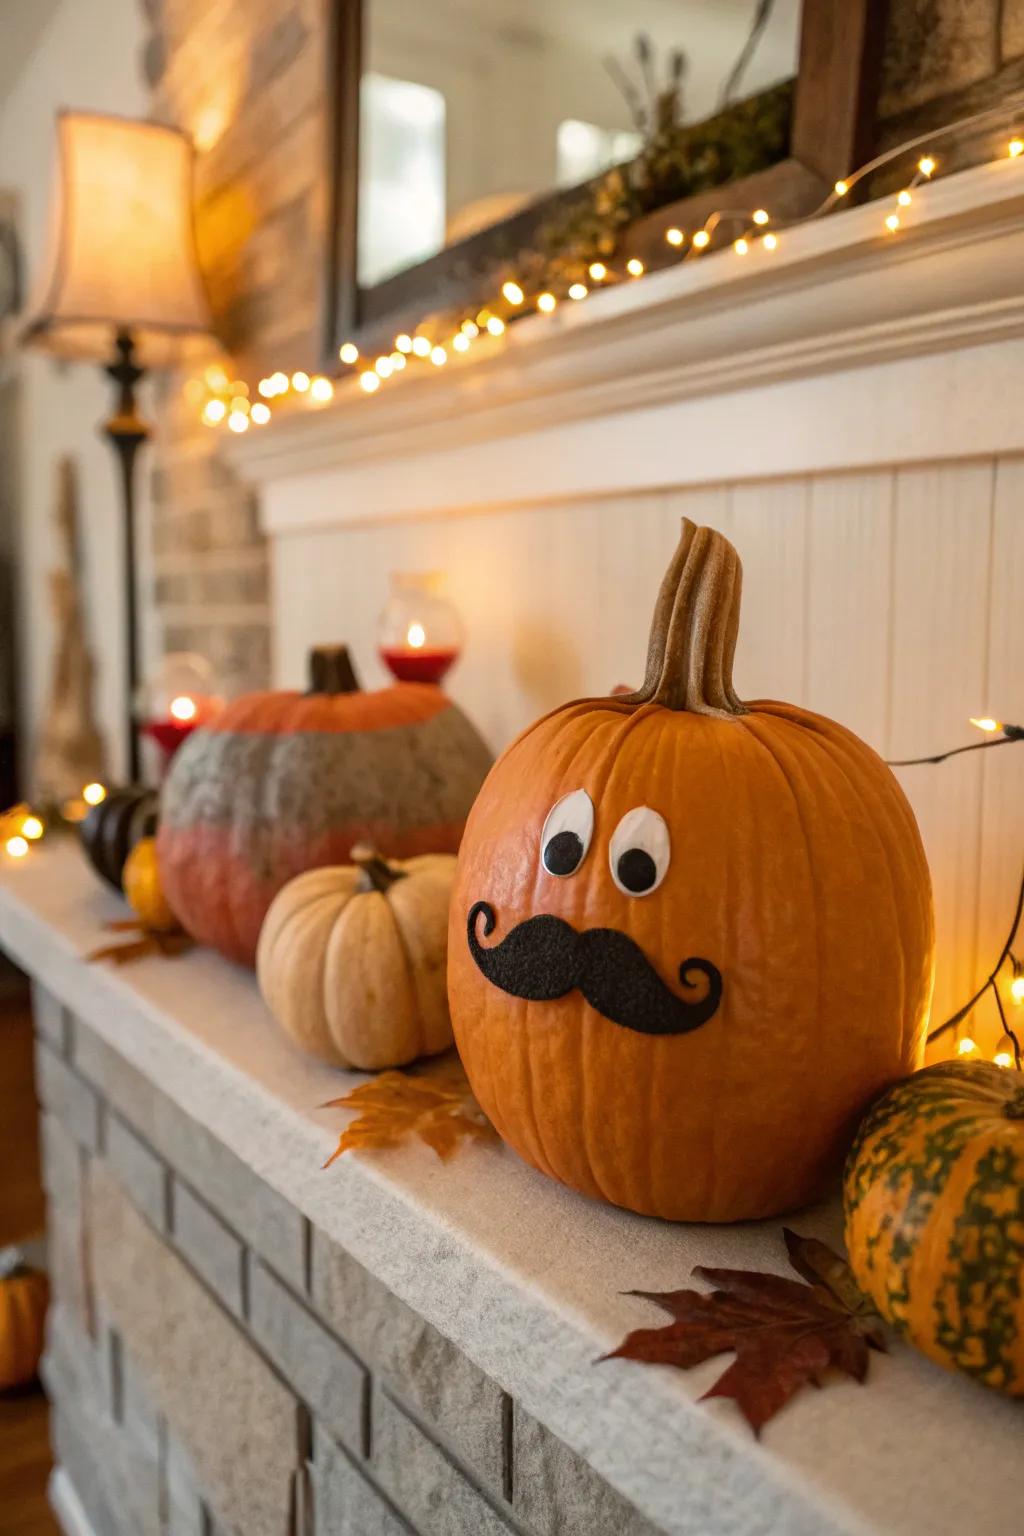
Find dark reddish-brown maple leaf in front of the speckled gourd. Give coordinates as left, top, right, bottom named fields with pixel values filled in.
left=603, top=1230, right=884, bottom=1435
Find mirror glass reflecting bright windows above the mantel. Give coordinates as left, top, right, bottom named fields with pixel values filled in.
left=358, top=0, right=800, bottom=287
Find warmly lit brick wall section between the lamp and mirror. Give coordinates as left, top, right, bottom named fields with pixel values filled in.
left=140, top=0, right=327, bottom=693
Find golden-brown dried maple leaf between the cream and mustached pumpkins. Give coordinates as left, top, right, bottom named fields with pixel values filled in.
left=322, top=1064, right=494, bottom=1167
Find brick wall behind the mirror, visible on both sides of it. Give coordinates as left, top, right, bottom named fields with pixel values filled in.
left=138, top=0, right=1024, bottom=693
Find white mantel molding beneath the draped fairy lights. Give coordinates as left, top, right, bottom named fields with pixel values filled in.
left=230, top=160, right=1024, bottom=535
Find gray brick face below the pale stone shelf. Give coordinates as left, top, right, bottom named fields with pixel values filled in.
left=35, top=988, right=656, bottom=1536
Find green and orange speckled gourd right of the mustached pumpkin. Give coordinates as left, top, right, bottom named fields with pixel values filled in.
left=843, top=1061, right=1024, bottom=1398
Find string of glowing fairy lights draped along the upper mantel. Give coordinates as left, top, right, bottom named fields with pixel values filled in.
left=186, top=103, right=1024, bottom=433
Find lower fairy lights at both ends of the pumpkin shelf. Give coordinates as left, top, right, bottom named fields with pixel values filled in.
left=0, top=716, right=1024, bottom=1072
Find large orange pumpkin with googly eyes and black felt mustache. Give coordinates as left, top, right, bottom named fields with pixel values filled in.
left=448, top=522, right=933, bottom=1221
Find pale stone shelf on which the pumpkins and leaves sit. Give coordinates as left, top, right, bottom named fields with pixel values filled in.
left=0, top=846, right=1024, bottom=1536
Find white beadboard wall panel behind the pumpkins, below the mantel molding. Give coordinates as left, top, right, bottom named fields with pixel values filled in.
left=273, top=458, right=1024, bottom=1051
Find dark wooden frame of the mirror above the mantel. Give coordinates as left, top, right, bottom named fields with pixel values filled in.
left=322, top=0, right=889, bottom=369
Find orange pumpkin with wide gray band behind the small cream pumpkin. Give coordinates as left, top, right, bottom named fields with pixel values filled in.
left=157, top=648, right=491, bottom=965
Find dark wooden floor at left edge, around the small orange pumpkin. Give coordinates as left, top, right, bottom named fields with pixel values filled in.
left=0, top=972, right=58, bottom=1536
